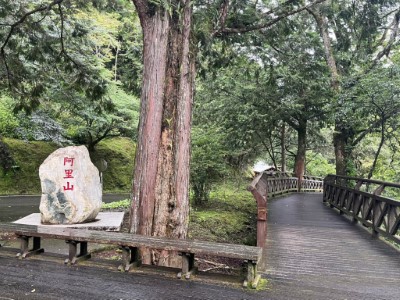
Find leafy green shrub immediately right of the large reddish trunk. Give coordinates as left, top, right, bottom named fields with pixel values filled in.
left=190, top=126, right=226, bottom=205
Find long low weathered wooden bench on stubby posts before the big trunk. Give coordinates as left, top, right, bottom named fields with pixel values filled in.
left=0, top=223, right=262, bottom=288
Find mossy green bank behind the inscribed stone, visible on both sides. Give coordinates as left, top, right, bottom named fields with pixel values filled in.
left=0, top=138, right=135, bottom=195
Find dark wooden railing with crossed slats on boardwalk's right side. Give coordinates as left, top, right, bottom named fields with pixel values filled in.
left=323, top=175, right=400, bottom=243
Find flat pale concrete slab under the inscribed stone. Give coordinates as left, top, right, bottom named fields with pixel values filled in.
left=13, top=212, right=125, bottom=231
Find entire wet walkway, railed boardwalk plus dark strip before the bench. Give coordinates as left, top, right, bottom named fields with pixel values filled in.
left=0, top=194, right=400, bottom=300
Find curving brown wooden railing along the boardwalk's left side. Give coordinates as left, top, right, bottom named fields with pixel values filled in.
left=248, top=172, right=323, bottom=247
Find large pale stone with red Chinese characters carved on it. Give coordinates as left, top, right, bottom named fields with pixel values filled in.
left=39, top=146, right=102, bottom=224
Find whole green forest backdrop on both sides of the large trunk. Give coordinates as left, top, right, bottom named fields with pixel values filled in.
left=0, top=0, right=400, bottom=202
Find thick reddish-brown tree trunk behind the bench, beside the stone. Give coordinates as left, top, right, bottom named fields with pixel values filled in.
left=130, top=0, right=195, bottom=266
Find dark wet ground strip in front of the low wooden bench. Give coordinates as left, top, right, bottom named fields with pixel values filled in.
left=0, top=250, right=268, bottom=300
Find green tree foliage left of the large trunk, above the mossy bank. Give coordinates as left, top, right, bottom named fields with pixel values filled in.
left=0, top=1, right=141, bottom=150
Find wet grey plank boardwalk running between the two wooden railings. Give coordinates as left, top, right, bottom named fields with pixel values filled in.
left=263, top=193, right=400, bottom=299
